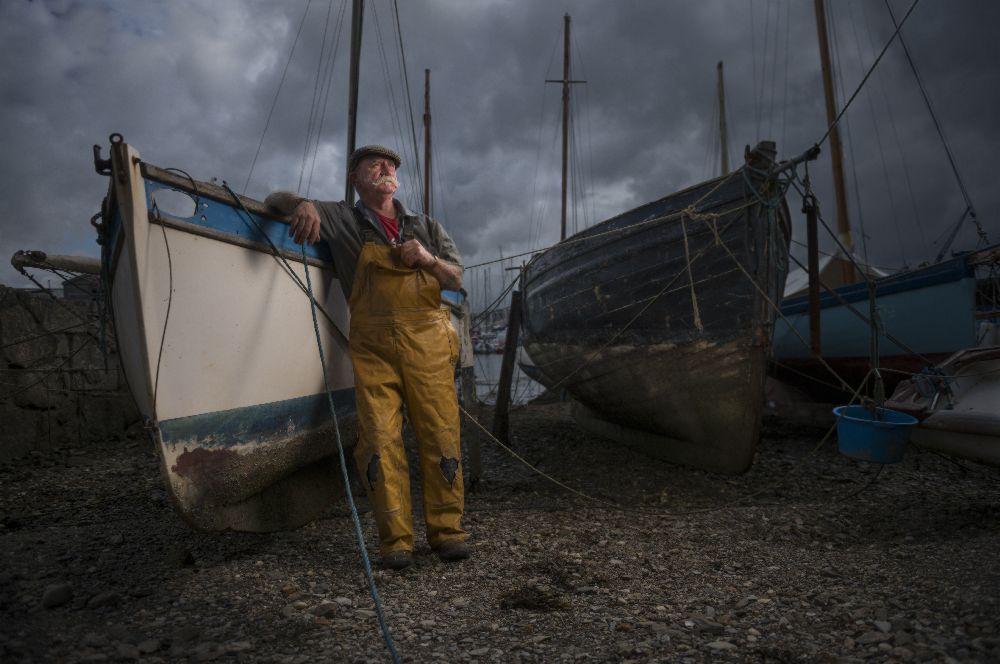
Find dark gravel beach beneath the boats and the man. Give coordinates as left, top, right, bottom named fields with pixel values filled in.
left=0, top=403, right=1000, bottom=663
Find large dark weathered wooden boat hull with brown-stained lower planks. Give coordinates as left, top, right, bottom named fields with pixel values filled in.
left=520, top=143, right=790, bottom=473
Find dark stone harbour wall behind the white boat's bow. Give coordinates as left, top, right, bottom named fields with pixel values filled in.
left=0, top=285, right=139, bottom=461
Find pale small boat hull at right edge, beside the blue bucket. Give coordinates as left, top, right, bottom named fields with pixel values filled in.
left=886, top=346, right=1000, bottom=466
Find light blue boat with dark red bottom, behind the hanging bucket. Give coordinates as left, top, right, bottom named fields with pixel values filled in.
left=774, top=246, right=1000, bottom=398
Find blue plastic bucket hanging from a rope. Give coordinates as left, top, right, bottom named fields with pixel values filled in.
left=833, top=406, right=917, bottom=463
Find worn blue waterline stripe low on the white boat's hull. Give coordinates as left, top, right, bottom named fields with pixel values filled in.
left=159, top=388, right=355, bottom=448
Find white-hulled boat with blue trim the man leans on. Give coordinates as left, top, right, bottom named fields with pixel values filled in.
left=94, top=135, right=354, bottom=531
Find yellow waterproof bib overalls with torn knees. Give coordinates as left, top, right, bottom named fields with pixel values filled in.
left=350, top=241, right=465, bottom=555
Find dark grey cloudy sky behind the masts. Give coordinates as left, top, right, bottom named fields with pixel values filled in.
left=0, top=0, right=1000, bottom=308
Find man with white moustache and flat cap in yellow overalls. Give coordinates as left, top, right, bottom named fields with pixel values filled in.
left=266, top=145, right=469, bottom=569
